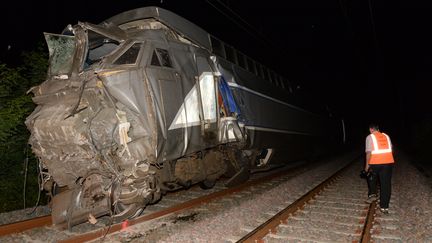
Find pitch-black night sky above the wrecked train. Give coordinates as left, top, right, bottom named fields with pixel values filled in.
left=0, top=0, right=432, bottom=142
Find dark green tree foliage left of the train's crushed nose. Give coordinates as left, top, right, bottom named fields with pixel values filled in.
left=0, top=44, right=48, bottom=212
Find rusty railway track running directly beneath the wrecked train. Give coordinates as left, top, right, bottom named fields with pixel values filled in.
left=0, top=159, right=311, bottom=242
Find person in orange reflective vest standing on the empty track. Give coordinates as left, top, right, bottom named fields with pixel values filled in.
left=365, top=124, right=394, bottom=214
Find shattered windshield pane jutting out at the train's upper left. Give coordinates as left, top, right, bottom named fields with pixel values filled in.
left=44, top=33, right=76, bottom=76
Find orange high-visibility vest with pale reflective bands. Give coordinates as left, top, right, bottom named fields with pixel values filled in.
left=369, top=132, right=394, bottom=165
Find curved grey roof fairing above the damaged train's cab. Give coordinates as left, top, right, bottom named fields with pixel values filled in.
left=104, top=7, right=211, bottom=50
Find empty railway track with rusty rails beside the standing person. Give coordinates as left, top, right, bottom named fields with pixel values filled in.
left=237, top=159, right=400, bottom=243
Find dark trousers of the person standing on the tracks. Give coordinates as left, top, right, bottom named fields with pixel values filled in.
left=367, top=163, right=393, bottom=208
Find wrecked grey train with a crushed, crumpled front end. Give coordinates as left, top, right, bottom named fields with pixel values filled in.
left=26, top=7, right=344, bottom=225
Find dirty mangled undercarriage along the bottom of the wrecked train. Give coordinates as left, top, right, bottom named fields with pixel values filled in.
left=45, top=145, right=257, bottom=227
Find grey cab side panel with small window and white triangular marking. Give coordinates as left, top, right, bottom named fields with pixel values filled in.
left=146, top=41, right=217, bottom=161
